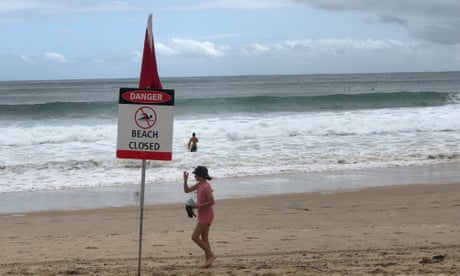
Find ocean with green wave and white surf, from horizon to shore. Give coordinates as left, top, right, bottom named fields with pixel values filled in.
left=0, top=72, right=460, bottom=211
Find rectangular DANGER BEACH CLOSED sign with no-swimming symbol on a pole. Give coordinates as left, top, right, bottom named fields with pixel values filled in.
left=117, top=88, right=174, bottom=160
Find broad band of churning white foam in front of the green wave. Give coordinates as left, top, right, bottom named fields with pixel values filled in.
left=0, top=105, right=460, bottom=192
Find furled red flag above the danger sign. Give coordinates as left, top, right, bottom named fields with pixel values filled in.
left=139, top=14, right=163, bottom=89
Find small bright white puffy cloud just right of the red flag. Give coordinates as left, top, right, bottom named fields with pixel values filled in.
left=155, top=38, right=229, bottom=58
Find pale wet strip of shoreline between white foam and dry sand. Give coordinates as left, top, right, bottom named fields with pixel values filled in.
left=0, top=162, right=460, bottom=214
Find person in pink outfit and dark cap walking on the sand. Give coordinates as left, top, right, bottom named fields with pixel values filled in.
left=183, top=166, right=216, bottom=268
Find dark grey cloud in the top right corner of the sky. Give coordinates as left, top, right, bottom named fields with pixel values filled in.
left=292, top=0, right=460, bottom=45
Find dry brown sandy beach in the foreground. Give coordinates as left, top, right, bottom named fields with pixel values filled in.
left=0, top=183, right=460, bottom=275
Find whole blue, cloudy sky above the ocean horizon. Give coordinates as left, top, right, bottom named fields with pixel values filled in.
left=0, top=0, right=460, bottom=81
